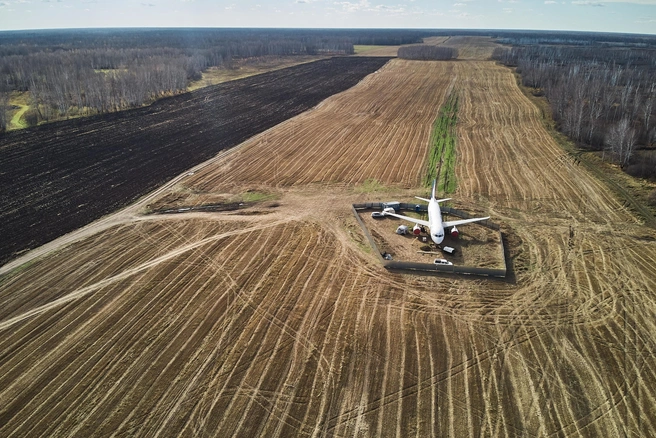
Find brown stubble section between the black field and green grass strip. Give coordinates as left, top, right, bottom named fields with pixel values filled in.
left=170, top=59, right=454, bottom=202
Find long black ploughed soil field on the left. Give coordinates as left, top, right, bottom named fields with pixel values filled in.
left=0, top=57, right=388, bottom=265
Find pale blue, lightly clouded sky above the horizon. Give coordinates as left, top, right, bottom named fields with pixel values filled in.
left=0, top=0, right=656, bottom=34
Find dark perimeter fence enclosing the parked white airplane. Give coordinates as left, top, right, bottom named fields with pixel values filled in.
left=352, top=202, right=507, bottom=278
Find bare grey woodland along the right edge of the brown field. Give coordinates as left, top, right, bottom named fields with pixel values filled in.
left=493, top=45, right=656, bottom=178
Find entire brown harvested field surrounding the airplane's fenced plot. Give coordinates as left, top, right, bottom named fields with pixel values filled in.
left=0, top=38, right=656, bottom=437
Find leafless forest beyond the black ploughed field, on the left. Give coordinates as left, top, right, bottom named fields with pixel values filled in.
left=0, top=29, right=421, bottom=128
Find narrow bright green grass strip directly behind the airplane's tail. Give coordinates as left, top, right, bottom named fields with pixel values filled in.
left=424, top=93, right=458, bottom=193
